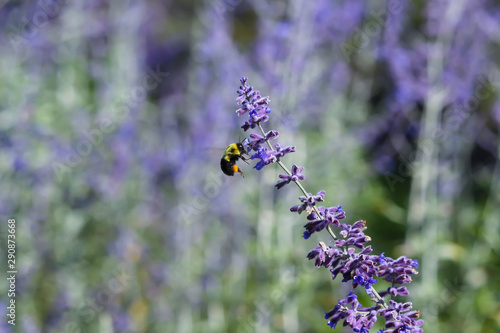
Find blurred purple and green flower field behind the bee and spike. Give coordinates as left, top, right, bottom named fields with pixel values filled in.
left=0, top=0, right=500, bottom=333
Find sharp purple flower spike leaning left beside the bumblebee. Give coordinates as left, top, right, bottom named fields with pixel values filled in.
left=230, top=77, right=423, bottom=333
